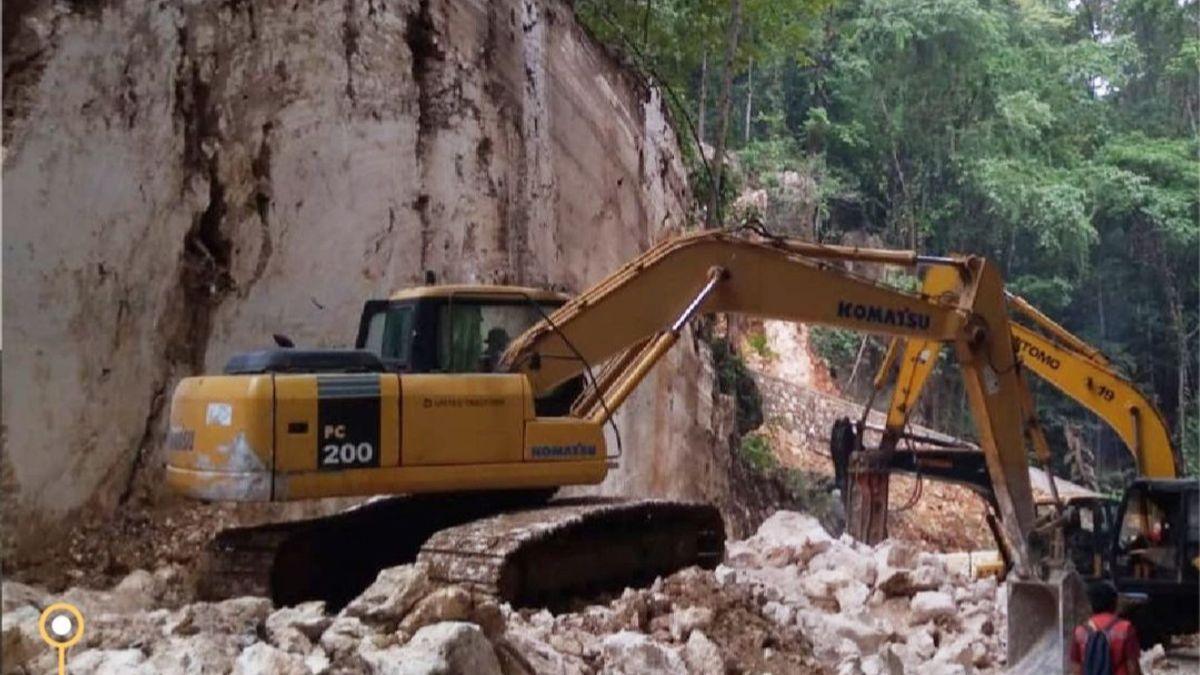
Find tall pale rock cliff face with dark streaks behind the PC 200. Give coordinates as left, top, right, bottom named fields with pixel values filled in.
left=0, top=0, right=728, bottom=550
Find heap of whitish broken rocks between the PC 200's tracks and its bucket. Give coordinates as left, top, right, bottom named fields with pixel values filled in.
left=716, top=512, right=1006, bottom=675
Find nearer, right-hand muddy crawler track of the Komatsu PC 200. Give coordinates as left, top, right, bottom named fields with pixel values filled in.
left=418, top=498, right=725, bottom=607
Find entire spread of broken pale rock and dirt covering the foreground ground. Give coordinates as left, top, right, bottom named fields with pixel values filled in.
left=2, top=512, right=1003, bottom=675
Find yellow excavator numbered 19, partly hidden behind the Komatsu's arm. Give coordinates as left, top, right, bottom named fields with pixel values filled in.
left=844, top=263, right=1200, bottom=647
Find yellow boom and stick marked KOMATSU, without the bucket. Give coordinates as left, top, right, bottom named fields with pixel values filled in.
left=502, top=232, right=1036, bottom=577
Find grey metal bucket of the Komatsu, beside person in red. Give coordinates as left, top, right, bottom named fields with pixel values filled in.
left=1007, top=569, right=1091, bottom=675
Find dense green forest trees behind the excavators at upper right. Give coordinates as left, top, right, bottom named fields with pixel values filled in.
left=578, top=0, right=1200, bottom=479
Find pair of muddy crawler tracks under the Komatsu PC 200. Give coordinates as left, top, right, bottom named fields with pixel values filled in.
left=196, top=490, right=725, bottom=610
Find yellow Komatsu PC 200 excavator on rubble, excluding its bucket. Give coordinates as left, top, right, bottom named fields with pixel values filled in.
left=167, top=232, right=1082, bottom=662
